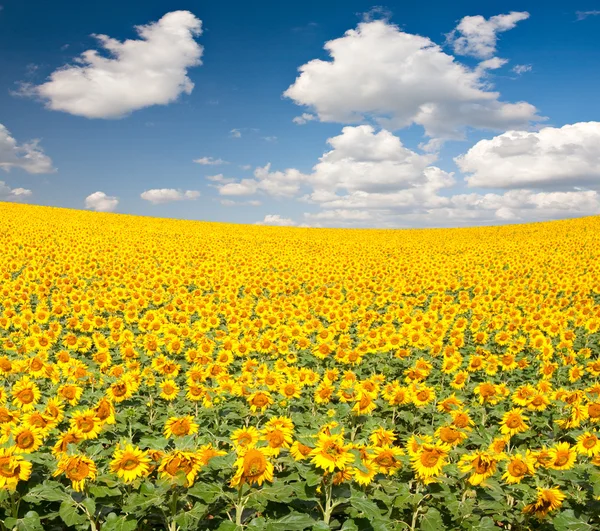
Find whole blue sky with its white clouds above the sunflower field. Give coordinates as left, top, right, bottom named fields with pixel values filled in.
left=0, top=0, right=600, bottom=227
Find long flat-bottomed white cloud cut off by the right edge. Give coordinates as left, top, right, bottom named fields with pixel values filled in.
left=455, top=122, right=600, bottom=188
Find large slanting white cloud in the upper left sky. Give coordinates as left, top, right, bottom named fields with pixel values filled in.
left=22, top=11, right=203, bottom=118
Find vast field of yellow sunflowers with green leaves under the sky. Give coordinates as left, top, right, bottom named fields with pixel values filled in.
left=0, top=203, right=600, bottom=531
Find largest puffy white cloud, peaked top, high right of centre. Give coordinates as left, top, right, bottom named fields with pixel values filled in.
left=284, top=20, right=541, bottom=138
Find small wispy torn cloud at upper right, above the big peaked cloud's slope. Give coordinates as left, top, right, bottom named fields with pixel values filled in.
left=448, top=11, right=529, bottom=59
